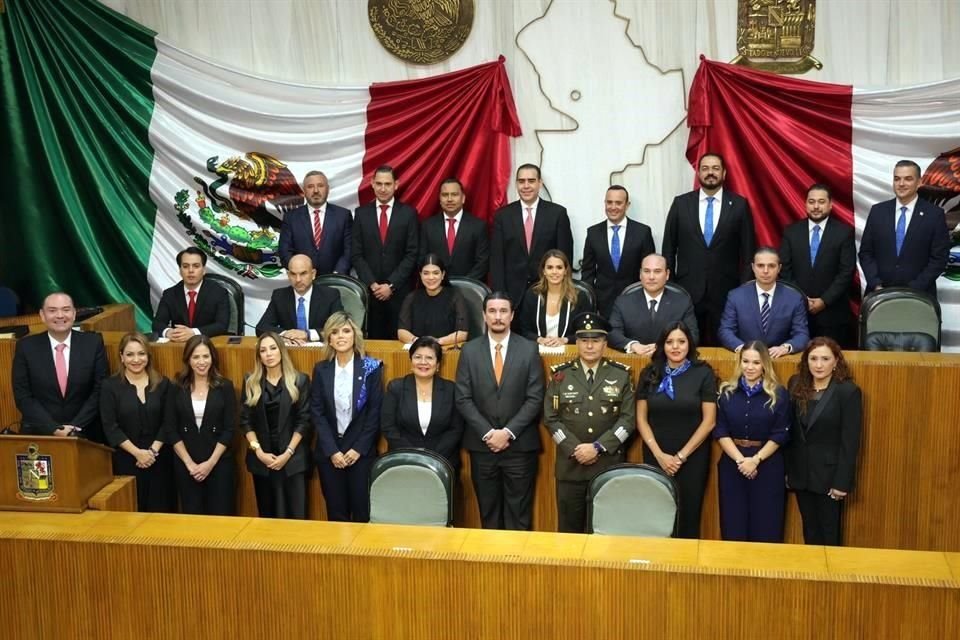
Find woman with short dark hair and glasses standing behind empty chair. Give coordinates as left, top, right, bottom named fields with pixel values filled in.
left=380, top=336, right=463, bottom=469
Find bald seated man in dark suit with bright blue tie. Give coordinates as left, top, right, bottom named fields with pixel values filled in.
left=257, top=254, right=343, bottom=346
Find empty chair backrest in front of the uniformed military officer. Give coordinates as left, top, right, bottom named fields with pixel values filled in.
left=587, top=464, right=680, bottom=538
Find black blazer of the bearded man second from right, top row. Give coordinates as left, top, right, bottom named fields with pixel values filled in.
left=780, top=216, right=857, bottom=325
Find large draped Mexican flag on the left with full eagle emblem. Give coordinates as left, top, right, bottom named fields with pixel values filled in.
left=0, top=0, right=520, bottom=328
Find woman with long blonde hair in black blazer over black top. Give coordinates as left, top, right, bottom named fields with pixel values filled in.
left=240, top=331, right=310, bottom=520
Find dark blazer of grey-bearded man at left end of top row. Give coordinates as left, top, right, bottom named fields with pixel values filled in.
left=277, top=202, right=353, bottom=274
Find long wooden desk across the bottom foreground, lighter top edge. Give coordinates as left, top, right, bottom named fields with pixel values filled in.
left=0, top=512, right=960, bottom=640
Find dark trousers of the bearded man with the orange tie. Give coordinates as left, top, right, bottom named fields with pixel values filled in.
left=470, top=449, right=537, bottom=531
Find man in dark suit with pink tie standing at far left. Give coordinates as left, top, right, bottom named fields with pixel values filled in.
left=11, top=293, right=107, bottom=442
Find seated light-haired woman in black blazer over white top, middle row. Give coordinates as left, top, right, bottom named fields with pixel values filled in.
left=519, top=249, right=591, bottom=347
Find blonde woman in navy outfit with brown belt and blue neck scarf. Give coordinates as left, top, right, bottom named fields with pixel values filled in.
left=713, top=340, right=791, bottom=542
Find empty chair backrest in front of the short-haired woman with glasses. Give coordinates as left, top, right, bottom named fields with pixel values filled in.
left=370, top=449, right=454, bottom=527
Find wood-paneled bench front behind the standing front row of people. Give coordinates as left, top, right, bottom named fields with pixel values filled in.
left=0, top=333, right=960, bottom=551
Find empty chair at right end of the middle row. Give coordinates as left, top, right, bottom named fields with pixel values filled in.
left=860, top=287, right=941, bottom=352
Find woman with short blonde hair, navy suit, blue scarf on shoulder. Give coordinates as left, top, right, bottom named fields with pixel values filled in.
left=310, top=311, right=383, bottom=522
